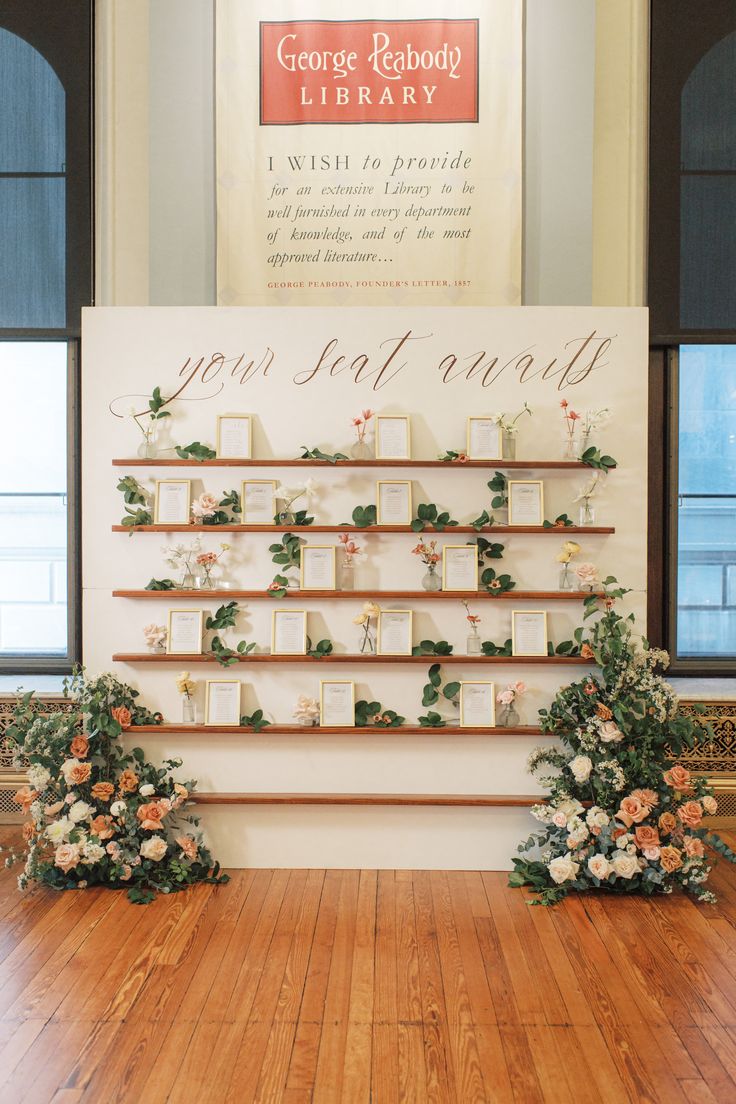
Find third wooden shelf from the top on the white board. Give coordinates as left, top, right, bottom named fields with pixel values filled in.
left=113, top=586, right=602, bottom=603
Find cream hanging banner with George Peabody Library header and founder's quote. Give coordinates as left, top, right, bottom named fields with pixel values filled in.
left=216, top=0, right=522, bottom=306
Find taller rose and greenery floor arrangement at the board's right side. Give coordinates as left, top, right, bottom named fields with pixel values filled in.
left=509, top=590, right=736, bottom=904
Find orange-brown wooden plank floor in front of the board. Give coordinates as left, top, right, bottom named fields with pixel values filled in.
left=0, top=829, right=736, bottom=1104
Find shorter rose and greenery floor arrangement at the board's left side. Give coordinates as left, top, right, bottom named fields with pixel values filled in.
left=6, top=671, right=227, bottom=904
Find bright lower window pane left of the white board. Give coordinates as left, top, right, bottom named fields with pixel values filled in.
left=0, top=341, right=67, bottom=658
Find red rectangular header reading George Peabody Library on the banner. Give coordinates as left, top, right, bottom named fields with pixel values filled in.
left=260, top=19, right=478, bottom=126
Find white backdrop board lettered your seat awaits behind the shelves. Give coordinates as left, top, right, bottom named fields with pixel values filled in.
left=83, top=307, right=647, bottom=869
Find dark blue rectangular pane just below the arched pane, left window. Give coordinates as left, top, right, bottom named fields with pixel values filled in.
left=0, top=177, right=66, bottom=329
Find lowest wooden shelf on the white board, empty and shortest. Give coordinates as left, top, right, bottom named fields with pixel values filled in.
left=192, top=793, right=544, bottom=808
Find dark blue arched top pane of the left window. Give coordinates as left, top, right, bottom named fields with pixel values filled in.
left=0, top=28, right=66, bottom=172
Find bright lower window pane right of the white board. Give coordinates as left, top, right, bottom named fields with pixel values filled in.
left=678, top=346, right=736, bottom=657
